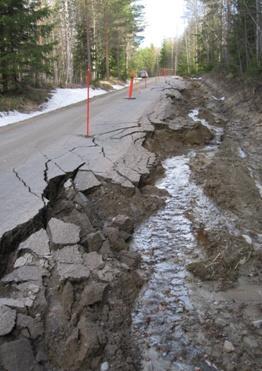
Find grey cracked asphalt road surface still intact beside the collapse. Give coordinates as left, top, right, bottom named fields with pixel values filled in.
left=0, top=79, right=165, bottom=238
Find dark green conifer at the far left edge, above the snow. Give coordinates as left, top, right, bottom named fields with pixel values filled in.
left=0, top=0, right=52, bottom=92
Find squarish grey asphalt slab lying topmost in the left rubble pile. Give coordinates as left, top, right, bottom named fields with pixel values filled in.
left=48, top=218, right=80, bottom=245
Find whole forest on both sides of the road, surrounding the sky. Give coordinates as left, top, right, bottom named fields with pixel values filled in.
left=0, top=0, right=262, bottom=93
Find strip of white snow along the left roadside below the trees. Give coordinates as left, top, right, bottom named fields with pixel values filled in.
left=0, top=85, right=125, bottom=127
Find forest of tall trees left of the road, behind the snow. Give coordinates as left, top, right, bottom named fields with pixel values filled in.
left=0, top=0, right=143, bottom=93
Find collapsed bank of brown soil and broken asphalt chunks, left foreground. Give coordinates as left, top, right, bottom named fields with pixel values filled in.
left=0, top=142, right=170, bottom=371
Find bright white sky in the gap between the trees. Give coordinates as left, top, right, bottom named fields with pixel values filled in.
left=141, top=0, right=185, bottom=47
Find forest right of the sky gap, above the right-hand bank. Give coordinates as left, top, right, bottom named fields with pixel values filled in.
left=133, top=0, right=262, bottom=76
